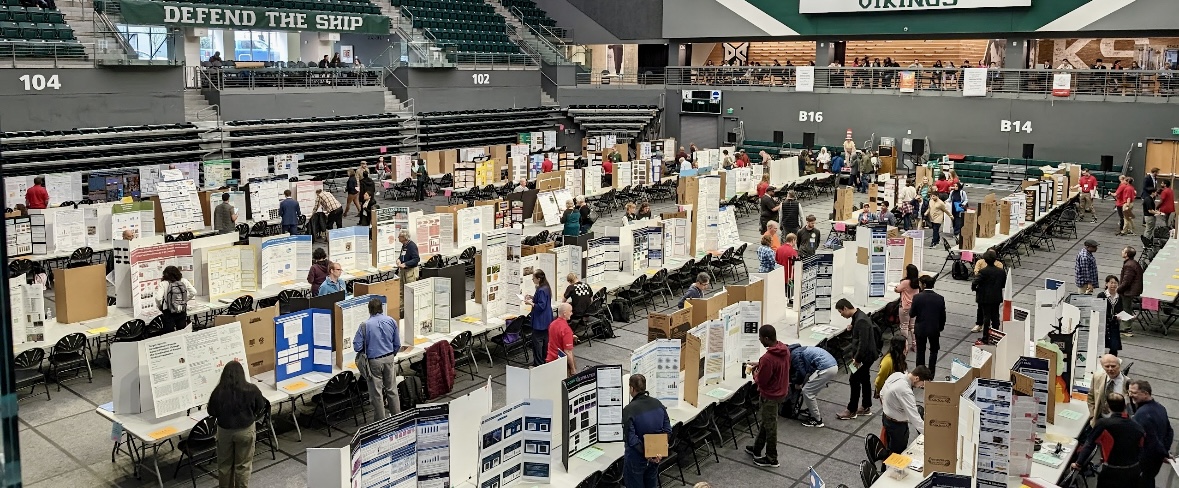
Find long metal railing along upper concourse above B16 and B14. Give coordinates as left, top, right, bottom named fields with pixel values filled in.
left=650, top=66, right=1179, bottom=101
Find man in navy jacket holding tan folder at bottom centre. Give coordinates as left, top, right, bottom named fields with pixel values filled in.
left=623, top=374, right=671, bottom=488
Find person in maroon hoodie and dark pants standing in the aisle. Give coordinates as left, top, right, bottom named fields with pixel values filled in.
left=745, top=324, right=790, bottom=468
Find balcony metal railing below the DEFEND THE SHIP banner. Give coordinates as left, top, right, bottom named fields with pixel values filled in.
left=187, top=66, right=384, bottom=90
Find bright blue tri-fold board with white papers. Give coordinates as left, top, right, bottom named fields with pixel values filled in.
left=275, top=309, right=331, bottom=385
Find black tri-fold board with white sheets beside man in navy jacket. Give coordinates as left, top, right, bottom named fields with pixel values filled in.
left=561, top=365, right=624, bottom=469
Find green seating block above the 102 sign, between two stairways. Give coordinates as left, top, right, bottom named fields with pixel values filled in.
left=390, top=0, right=520, bottom=54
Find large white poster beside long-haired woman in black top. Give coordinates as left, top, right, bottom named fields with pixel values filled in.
left=138, top=322, right=245, bottom=418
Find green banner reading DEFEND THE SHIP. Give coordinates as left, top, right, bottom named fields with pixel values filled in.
left=120, top=0, right=389, bottom=34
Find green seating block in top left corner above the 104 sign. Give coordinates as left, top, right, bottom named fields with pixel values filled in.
left=0, top=0, right=86, bottom=58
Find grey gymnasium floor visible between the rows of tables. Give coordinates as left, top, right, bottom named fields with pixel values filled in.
left=19, top=183, right=1179, bottom=488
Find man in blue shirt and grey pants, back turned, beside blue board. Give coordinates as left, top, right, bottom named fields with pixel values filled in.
left=351, top=297, right=401, bottom=421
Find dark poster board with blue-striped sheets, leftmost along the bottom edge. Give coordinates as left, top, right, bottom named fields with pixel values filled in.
left=349, top=403, right=452, bottom=488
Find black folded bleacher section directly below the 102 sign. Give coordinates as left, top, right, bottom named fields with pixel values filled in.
left=417, top=107, right=558, bottom=150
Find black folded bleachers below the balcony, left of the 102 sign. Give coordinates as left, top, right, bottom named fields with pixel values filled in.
left=222, top=113, right=416, bottom=174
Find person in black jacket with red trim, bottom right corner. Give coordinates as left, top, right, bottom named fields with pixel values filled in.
left=1073, top=393, right=1136, bottom=488
